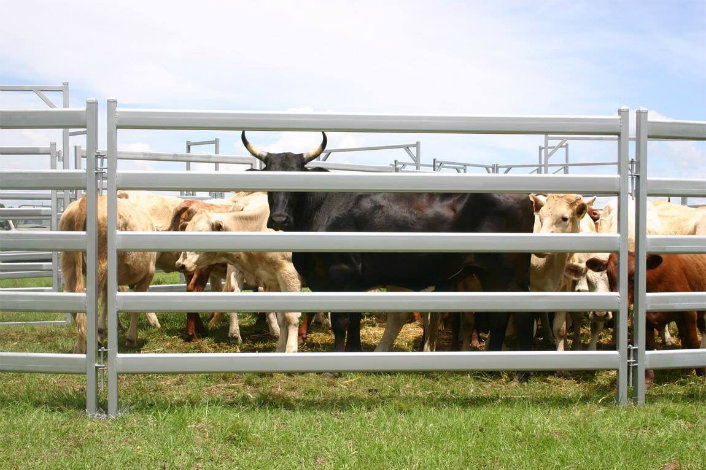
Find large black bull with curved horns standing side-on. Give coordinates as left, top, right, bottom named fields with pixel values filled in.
left=241, top=132, right=534, bottom=351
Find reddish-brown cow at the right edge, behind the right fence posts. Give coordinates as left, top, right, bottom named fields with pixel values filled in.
left=586, top=252, right=706, bottom=385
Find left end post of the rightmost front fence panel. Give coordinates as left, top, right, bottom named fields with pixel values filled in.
left=633, top=109, right=653, bottom=405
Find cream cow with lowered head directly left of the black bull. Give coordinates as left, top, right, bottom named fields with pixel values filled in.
left=179, top=208, right=301, bottom=352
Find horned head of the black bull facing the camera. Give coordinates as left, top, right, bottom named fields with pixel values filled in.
left=241, top=131, right=326, bottom=230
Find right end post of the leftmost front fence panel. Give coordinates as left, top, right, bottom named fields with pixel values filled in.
left=86, top=99, right=98, bottom=414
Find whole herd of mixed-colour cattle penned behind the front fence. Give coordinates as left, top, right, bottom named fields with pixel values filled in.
left=59, top=132, right=706, bottom=382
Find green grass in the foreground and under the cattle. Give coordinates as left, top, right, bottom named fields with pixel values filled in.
left=0, top=278, right=706, bottom=469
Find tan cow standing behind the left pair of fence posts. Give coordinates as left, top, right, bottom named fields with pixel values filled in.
left=59, top=196, right=156, bottom=354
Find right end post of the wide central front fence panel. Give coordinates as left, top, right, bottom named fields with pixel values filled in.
left=615, top=108, right=631, bottom=406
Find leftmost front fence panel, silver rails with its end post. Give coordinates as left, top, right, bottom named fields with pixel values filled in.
left=0, top=100, right=98, bottom=414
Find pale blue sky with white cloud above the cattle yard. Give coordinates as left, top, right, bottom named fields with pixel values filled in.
left=0, top=0, right=706, bottom=200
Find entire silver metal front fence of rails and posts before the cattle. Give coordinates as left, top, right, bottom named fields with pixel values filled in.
left=0, top=100, right=706, bottom=416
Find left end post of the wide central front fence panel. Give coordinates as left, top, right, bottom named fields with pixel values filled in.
left=106, top=99, right=118, bottom=417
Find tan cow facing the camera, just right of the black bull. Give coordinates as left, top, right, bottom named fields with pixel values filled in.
left=529, top=194, right=596, bottom=351
